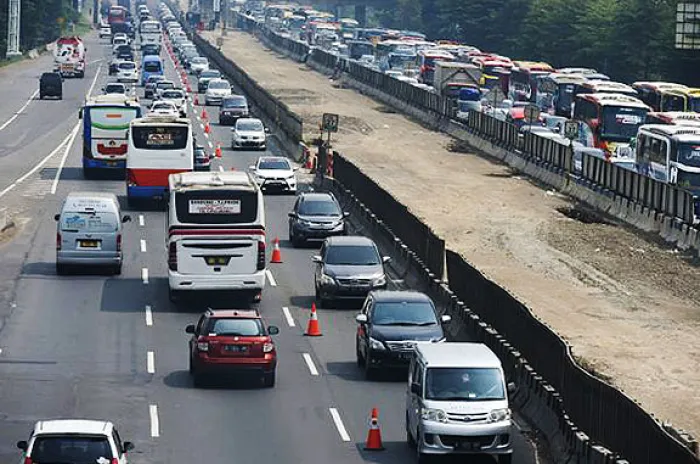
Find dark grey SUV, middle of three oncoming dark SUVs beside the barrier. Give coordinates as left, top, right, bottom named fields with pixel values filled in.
left=311, top=235, right=391, bottom=306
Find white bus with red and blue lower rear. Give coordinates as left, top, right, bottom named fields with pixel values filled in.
left=126, top=116, right=194, bottom=204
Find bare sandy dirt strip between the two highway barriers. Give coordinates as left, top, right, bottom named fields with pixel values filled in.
left=200, top=30, right=700, bottom=436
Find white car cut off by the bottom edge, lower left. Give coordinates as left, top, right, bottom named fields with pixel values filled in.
left=17, top=419, right=134, bottom=464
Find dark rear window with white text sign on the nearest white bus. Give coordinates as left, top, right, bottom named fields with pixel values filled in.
left=175, top=190, right=258, bottom=224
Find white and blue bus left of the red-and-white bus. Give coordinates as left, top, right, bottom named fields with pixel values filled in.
left=80, top=94, right=141, bottom=179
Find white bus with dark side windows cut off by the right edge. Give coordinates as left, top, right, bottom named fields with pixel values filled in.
left=636, top=124, right=700, bottom=216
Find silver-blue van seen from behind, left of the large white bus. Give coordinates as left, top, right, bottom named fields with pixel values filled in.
left=54, top=192, right=131, bottom=274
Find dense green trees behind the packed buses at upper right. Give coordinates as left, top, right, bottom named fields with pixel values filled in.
left=373, top=0, right=700, bottom=87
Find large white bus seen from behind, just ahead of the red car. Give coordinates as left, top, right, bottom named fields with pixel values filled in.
left=166, top=171, right=266, bottom=301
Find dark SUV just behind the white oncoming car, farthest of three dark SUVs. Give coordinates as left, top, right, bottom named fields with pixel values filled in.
left=289, top=192, right=349, bottom=247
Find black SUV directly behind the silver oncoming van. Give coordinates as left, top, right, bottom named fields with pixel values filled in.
left=355, top=290, right=452, bottom=379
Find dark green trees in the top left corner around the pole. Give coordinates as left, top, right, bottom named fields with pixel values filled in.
left=0, top=0, right=83, bottom=59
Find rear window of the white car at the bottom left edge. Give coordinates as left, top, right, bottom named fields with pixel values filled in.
left=31, top=435, right=114, bottom=464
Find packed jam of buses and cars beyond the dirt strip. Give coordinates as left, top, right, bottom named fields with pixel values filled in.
left=260, top=2, right=700, bottom=201
